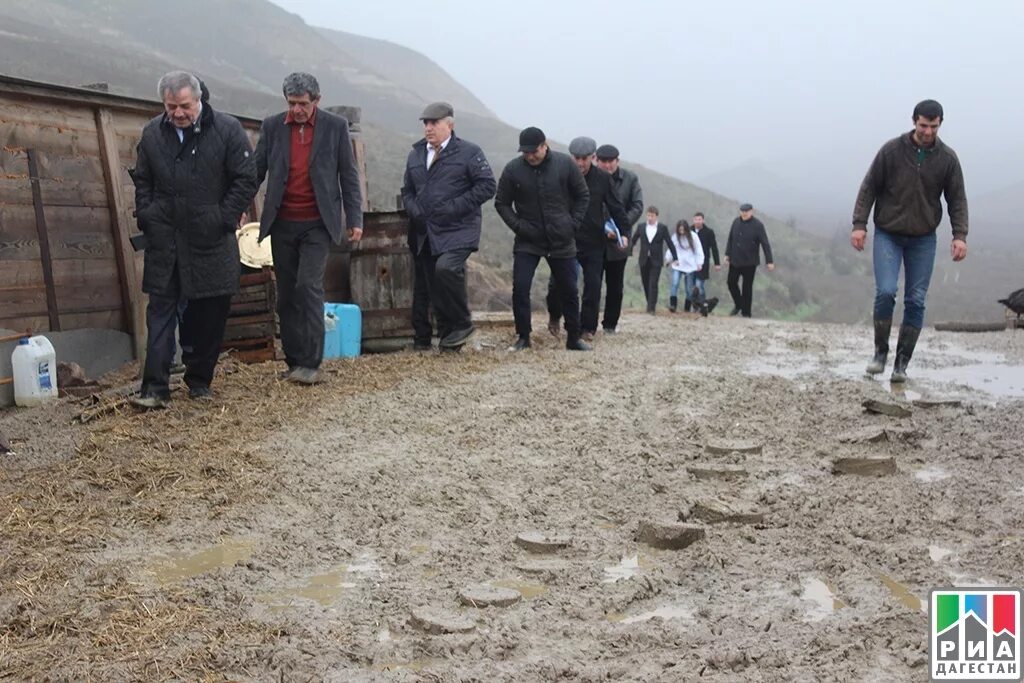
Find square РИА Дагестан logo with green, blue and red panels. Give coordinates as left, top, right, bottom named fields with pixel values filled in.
left=929, top=588, right=1022, bottom=681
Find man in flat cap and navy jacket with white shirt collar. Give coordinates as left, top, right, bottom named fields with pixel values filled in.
left=401, top=102, right=496, bottom=351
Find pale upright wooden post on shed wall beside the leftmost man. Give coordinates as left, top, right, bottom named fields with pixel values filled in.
left=96, top=108, right=146, bottom=359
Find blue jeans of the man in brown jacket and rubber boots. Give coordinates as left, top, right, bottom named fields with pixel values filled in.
left=872, top=228, right=936, bottom=330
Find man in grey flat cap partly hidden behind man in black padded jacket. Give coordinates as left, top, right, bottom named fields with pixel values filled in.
left=548, top=137, right=629, bottom=342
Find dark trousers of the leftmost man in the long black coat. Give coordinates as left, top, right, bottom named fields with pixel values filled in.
left=142, top=294, right=231, bottom=398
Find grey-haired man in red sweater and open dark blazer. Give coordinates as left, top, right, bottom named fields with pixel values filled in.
left=256, top=73, right=362, bottom=384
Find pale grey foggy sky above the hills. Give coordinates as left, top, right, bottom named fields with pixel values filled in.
left=273, top=0, right=1024, bottom=214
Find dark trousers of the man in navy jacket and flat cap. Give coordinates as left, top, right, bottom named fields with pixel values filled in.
left=413, top=242, right=473, bottom=344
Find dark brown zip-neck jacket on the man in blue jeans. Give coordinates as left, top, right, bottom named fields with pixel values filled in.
left=853, top=132, right=968, bottom=241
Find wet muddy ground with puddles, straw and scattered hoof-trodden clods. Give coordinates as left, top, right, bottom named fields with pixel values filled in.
left=0, top=314, right=1024, bottom=681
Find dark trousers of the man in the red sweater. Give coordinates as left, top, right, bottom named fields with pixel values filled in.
left=270, top=219, right=331, bottom=370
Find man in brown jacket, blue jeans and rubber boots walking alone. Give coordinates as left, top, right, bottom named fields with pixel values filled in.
left=850, top=99, right=968, bottom=383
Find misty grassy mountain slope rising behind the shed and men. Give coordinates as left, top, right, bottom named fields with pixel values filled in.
left=0, top=0, right=1009, bottom=321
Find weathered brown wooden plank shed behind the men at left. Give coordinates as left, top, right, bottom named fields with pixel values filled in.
left=0, top=76, right=412, bottom=357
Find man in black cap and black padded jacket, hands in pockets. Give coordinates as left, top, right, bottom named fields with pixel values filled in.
left=495, top=127, right=590, bottom=351
